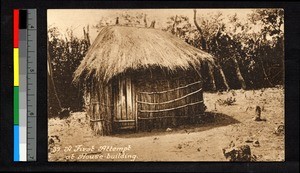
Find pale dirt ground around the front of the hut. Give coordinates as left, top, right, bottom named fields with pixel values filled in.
left=48, top=87, right=285, bottom=161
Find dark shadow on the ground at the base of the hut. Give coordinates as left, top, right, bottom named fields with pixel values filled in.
left=113, top=112, right=240, bottom=138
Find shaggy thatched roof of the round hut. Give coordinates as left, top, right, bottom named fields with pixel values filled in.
left=74, top=26, right=213, bottom=81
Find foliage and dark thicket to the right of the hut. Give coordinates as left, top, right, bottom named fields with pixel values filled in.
left=163, top=9, right=284, bottom=89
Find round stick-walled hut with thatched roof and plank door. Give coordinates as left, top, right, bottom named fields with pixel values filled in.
left=74, top=26, right=214, bottom=135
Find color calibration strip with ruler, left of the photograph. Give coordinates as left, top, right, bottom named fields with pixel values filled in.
left=13, top=9, right=37, bottom=161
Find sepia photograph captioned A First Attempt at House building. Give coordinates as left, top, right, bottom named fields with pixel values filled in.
left=47, top=8, right=285, bottom=162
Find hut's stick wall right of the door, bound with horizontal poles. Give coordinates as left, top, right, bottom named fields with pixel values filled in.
left=134, top=69, right=204, bottom=131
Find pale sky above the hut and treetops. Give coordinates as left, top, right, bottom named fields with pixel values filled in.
left=47, top=9, right=253, bottom=42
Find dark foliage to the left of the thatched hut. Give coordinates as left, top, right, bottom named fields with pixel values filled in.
left=48, top=27, right=89, bottom=116
